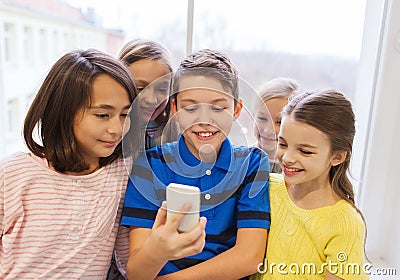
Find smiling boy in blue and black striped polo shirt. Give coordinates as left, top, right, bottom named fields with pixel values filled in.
left=122, top=49, right=270, bottom=279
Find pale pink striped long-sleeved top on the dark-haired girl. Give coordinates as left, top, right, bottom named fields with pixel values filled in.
left=0, top=153, right=131, bottom=279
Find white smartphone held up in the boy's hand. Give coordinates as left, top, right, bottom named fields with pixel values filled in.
left=166, top=183, right=200, bottom=232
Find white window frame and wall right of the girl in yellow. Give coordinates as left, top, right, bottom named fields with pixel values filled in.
left=354, top=0, right=400, bottom=274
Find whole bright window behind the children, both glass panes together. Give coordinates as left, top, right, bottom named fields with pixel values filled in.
left=0, top=0, right=365, bottom=157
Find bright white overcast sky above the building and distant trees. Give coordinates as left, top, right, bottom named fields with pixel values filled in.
left=66, top=0, right=366, bottom=57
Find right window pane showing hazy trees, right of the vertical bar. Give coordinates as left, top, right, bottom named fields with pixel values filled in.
left=193, top=0, right=366, bottom=148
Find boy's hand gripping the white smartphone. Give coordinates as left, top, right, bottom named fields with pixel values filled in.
left=147, top=201, right=207, bottom=261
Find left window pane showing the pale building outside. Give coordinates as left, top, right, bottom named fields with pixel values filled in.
left=0, top=0, right=187, bottom=155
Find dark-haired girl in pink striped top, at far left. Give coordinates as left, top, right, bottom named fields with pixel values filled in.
left=0, top=49, right=136, bottom=279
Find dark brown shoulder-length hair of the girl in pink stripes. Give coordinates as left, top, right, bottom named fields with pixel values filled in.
left=23, top=49, right=137, bottom=172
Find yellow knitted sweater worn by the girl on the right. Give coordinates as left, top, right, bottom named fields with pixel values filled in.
left=251, top=173, right=369, bottom=280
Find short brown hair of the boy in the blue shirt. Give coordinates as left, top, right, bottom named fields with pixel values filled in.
left=172, top=49, right=239, bottom=104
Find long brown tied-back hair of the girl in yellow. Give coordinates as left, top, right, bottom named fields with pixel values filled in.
left=282, top=89, right=367, bottom=253
